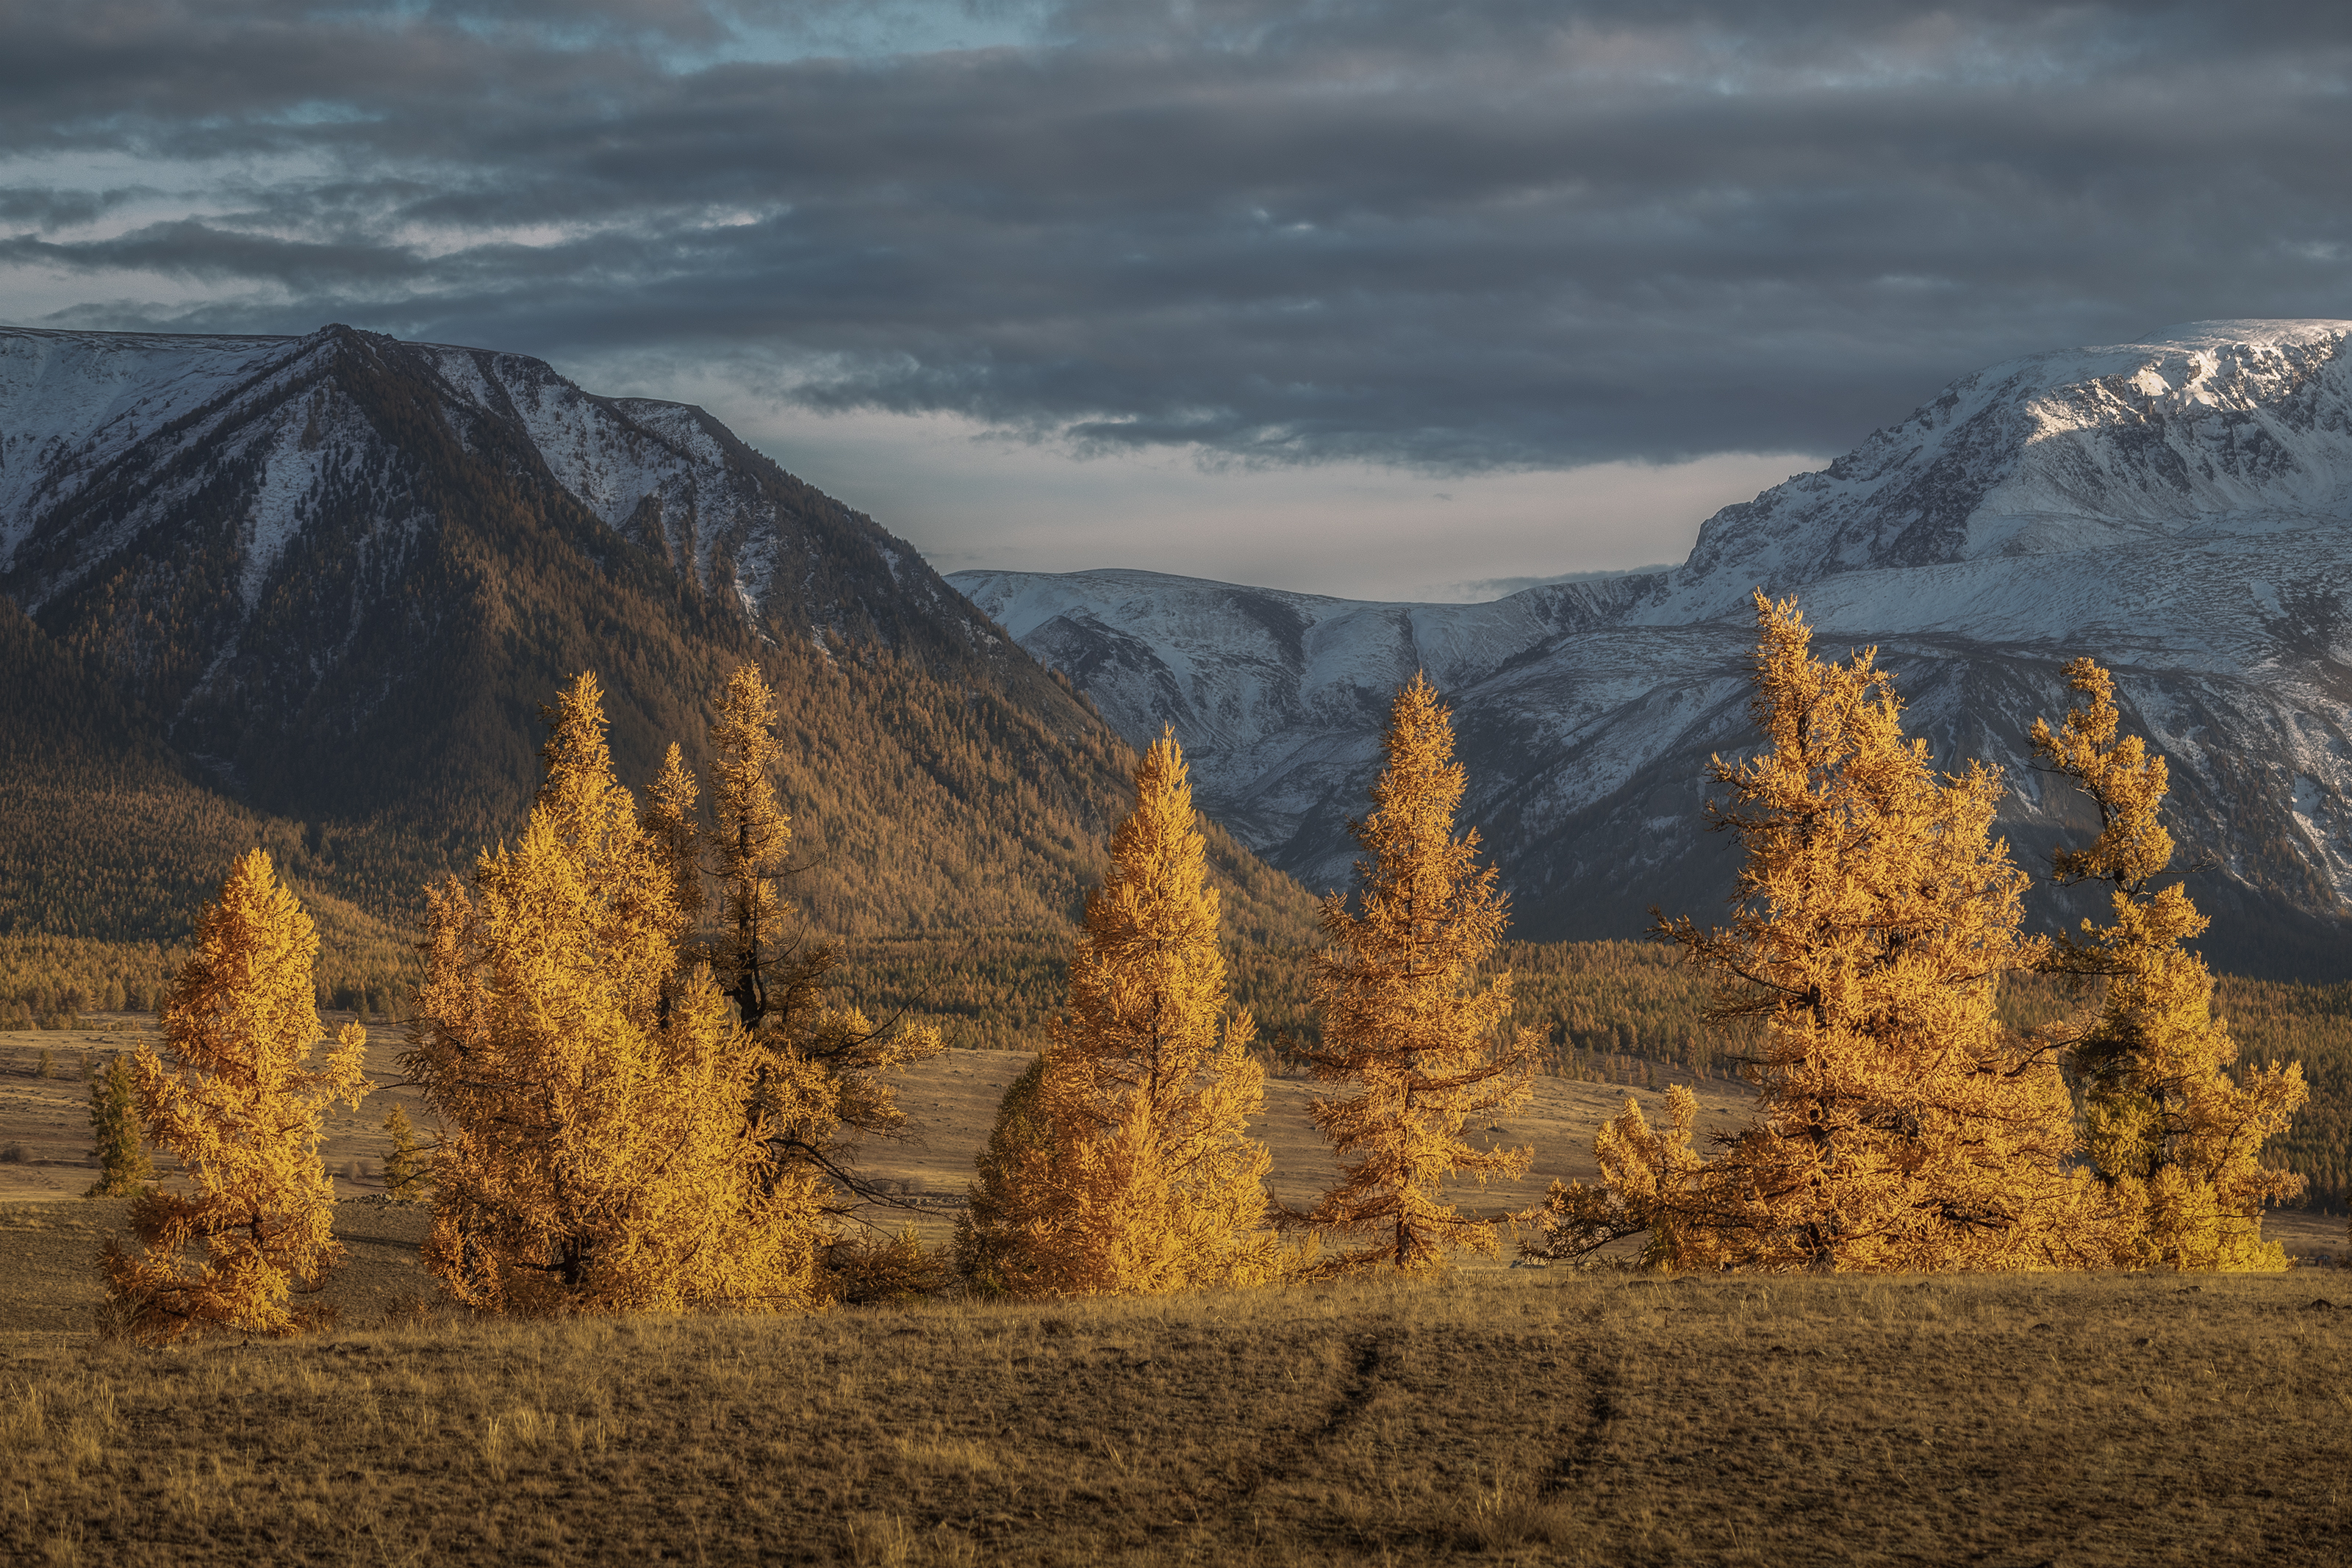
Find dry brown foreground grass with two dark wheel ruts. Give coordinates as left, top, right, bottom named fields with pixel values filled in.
left=0, top=1206, right=2352, bottom=1568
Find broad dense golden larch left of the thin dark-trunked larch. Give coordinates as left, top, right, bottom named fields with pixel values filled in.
left=404, top=675, right=823, bottom=1314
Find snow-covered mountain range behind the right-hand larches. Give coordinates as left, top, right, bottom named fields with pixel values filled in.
left=948, top=322, right=2352, bottom=974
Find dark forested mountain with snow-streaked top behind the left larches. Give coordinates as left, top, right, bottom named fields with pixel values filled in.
left=0, top=327, right=1308, bottom=959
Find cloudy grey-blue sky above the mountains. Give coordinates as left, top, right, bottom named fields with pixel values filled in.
left=0, top=0, right=2352, bottom=600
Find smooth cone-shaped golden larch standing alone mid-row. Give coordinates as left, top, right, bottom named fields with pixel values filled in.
left=960, top=736, right=1284, bottom=1295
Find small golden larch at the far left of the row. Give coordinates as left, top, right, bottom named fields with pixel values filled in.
left=106, top=849, right=369, bottom=1342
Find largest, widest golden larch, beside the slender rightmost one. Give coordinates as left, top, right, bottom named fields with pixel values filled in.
left=1529, top=592, right=2112, bottom=1272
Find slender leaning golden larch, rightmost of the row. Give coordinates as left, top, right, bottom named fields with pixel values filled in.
left=2032, top=658, right=2307, bottom=1270
